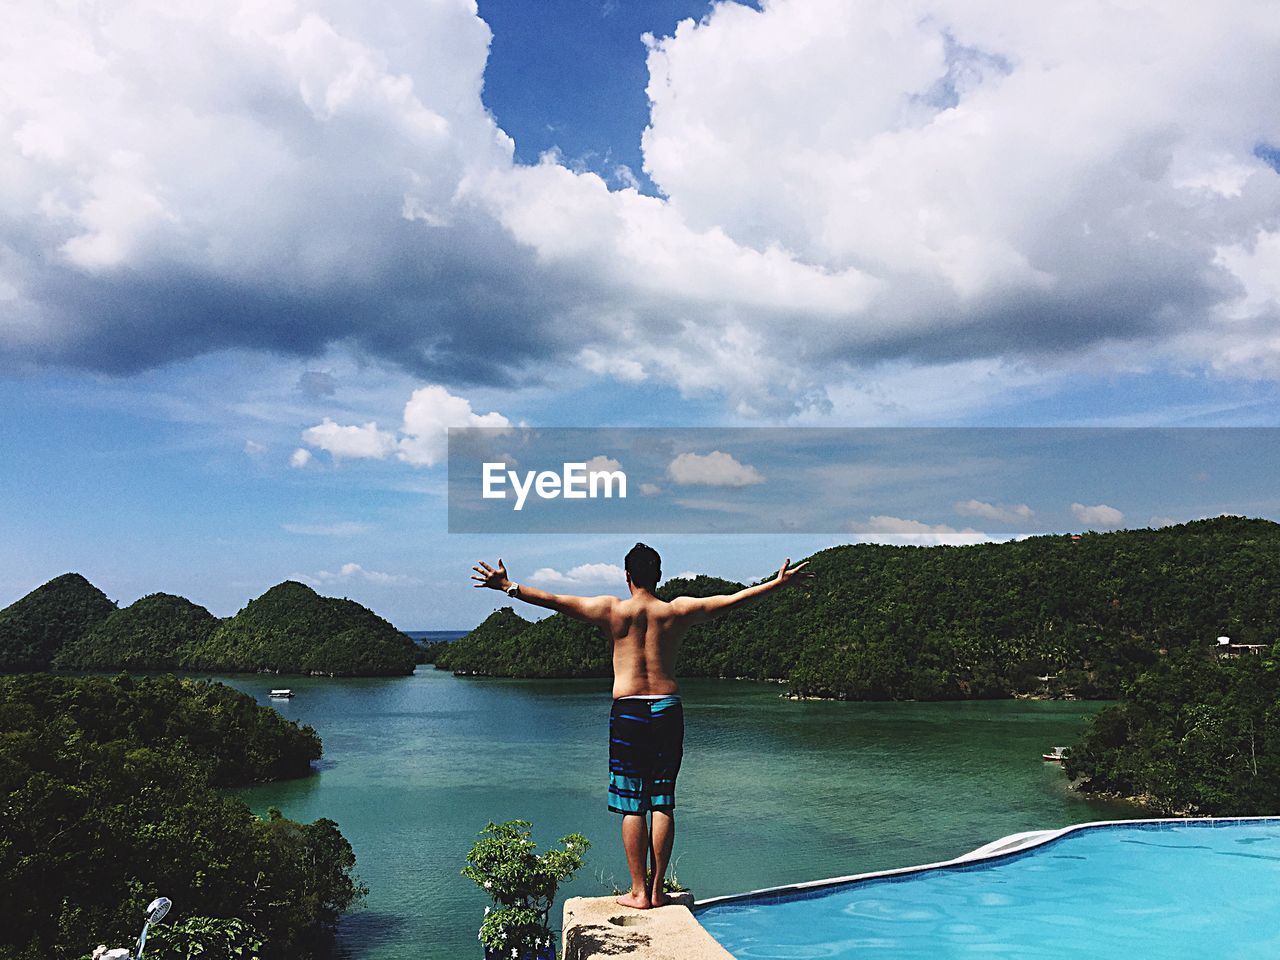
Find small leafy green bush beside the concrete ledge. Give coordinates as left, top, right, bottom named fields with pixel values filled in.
left=462, top=820, right=591, bottom=960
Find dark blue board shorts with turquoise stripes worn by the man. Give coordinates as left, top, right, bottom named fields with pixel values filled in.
left=609, top=696, right=685, bottom=814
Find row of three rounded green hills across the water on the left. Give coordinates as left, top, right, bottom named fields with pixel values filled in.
left=0, top=573, right=420, bottom=676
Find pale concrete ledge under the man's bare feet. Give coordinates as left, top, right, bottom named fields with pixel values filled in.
left=561, top=893, right=733, bottom=960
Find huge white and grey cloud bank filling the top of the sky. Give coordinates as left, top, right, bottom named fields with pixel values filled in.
left=0, top=0, right=1280, bottom=409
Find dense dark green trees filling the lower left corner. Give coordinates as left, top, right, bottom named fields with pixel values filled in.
left=0, top=675, right=362, bottom=960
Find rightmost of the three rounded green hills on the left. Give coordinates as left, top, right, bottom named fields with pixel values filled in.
left=184, top=580, right=417, bottom=676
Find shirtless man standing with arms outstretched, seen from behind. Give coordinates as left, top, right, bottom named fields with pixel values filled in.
left=471, top=543, right=809, bottom=910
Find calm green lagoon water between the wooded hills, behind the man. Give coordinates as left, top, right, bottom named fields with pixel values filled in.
left=219, top=667, right=1140, bottom=960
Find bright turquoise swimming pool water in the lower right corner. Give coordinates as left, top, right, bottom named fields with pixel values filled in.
left=698, top=819, right=1280, bottom=960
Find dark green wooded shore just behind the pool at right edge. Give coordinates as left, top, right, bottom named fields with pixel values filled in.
left=1065, top=646, right=1280, bottom=817
